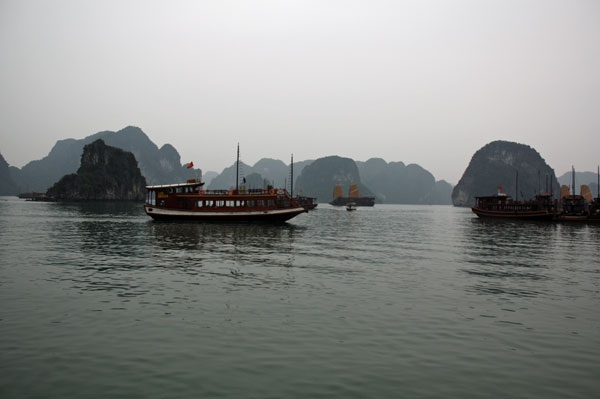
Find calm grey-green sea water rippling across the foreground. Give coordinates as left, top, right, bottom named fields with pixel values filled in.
left=0, top=197, right=600, bottom=399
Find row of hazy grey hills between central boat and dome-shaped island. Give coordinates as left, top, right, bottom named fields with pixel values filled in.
left=207, top=156, right=452, bottom=205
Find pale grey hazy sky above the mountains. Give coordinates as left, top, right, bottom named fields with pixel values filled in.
left=0, top=0, right=600, bottom=184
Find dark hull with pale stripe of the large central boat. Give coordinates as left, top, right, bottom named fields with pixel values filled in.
left=144, top=204, right=306, bottom=223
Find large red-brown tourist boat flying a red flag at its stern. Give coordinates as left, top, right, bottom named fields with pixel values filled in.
left=144, top=147, right=307, bottom=222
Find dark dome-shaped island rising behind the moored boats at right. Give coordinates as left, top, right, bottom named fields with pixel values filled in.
left=452, top=141, right=560, bottom=206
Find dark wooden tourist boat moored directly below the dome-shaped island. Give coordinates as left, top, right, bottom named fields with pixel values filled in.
left=471, top=187, right=554, bottom=220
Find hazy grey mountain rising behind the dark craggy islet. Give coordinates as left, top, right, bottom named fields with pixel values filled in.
left=11, top=126, right=200, bottom=192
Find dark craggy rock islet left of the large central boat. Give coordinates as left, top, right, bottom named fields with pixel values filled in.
left=47, top=139, right=146, bottom=201
